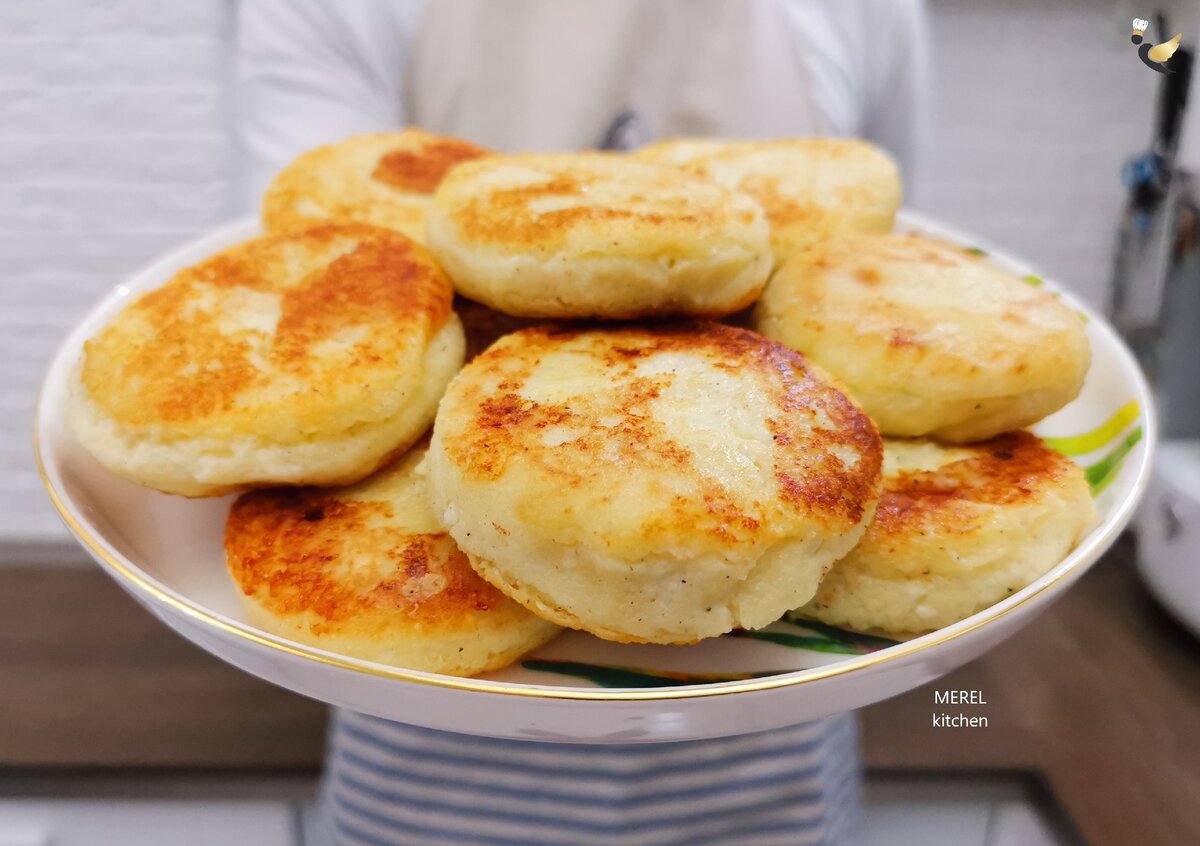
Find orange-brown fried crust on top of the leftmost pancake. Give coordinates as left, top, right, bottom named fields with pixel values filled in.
left=83, top=224, right=452, bottom=426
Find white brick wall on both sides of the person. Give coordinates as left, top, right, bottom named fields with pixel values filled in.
left=0, top=0, right=1176, bottom=562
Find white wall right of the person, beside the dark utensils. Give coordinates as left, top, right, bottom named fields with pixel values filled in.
left=917, top=0, right=1161, bottom=306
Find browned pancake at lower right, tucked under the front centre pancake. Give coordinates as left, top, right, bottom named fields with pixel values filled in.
left=802, top=432, right=1094, bottom=634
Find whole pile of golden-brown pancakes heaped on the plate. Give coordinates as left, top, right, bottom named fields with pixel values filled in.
left=65, top=131, right=1091, bottom=674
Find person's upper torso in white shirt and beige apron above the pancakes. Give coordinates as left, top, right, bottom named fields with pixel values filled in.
left=238, top=0, right=924, bottom=203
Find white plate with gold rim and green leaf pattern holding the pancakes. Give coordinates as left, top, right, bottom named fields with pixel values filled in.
left=35, top=212, right=1154, bottom=743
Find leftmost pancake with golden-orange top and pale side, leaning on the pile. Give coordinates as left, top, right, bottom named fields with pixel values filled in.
left=71, top=226, right=463, bottom=497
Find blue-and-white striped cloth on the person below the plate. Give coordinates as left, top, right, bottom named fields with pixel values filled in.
left=322, top=712, right=859, bottom=846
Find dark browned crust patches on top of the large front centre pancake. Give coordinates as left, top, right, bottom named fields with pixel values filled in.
left=445, top=322, right=882, bottom=546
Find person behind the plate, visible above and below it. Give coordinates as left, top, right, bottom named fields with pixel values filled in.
left=236, top=0, right=924, bottom=846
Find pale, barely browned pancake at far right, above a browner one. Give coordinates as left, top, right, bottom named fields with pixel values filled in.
left=755, top=234, right=1091, bottom=443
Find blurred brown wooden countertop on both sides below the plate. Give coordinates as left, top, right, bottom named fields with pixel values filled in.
left=0, top=540, right=1200, bottom=846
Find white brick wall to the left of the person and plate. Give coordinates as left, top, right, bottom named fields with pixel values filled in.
left=0, top=0, right=233, bottom=560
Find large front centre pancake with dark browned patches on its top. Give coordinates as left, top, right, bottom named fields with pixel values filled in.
left=427, top=323, right=882, bottom=643
